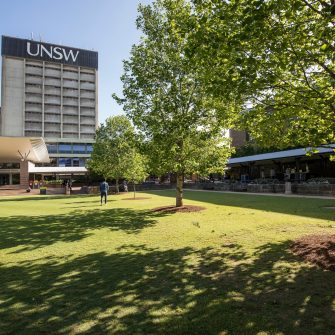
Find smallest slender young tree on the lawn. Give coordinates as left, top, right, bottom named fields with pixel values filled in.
left=125, top=149, right=148, bottom=198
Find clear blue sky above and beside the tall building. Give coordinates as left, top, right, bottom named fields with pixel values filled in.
left=0, top=0, right=151, bottom=122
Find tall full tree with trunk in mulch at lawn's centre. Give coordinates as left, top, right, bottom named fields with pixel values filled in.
left=115, top=0, right=230, bottom=207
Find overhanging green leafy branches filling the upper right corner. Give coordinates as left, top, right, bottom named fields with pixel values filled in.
left=189, top=0, right=335, bottom=147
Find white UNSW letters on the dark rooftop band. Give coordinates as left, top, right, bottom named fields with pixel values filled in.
left=27, top=42, right=79, bottom=62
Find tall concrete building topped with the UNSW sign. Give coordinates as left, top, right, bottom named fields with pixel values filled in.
left=0, top=36, right=98, bottom=178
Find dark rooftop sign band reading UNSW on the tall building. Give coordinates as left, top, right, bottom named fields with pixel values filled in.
left=1, top=36, right=98, bottom=69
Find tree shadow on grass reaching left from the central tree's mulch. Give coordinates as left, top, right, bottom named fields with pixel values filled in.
left=0, top=207, right=167, bottom=252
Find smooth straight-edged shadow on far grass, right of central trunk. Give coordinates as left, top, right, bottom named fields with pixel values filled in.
left=146, top=190, right=335, bottom=221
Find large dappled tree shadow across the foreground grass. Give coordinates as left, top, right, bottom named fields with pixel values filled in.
left=0, top=242, right=335, bottom=335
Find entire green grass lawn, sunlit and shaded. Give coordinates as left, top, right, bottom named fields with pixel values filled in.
left=0, top=191, right=335, bottom=335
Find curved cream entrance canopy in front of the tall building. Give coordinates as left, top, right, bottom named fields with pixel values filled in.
left=0, top=136, right=50, bottom=163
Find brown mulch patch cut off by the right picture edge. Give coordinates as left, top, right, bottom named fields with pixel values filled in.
left=291, top=234, right=335, bottom=271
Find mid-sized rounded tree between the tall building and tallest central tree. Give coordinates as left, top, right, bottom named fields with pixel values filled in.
left=88, top=115, right=135, bottom=193
